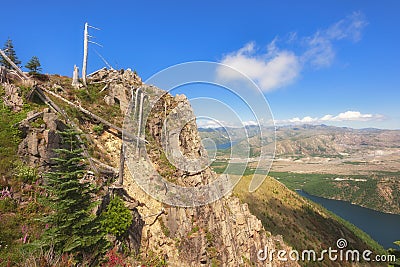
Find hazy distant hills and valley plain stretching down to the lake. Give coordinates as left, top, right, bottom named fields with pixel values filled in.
left=199, top=125, right=400, bottom=214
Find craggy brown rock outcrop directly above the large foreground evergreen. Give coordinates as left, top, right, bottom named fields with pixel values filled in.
left=18, top=108, right=66, bottom=170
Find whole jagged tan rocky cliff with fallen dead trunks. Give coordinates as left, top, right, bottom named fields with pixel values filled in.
left=13, top=69, right=297, bottom=266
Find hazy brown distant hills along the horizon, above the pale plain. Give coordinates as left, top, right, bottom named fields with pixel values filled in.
left=199, top=125, right=400, bottom=157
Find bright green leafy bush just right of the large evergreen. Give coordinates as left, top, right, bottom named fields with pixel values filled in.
left=101, top=196, right=133, bottom=239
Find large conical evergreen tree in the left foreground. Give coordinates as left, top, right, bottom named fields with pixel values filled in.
left=41, top=129, right=108, bottom=262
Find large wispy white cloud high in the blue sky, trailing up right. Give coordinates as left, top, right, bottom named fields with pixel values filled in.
left=217, top=12, right=367, bottom=92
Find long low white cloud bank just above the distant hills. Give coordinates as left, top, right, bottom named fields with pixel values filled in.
left=275, top=110, right=385, bottom=125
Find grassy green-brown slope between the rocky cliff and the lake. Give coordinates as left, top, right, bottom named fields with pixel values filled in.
left=234, top=175, right=385, bottom=266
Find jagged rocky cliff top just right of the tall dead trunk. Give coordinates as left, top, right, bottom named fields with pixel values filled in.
left=89, top=69, right=142, bottom=114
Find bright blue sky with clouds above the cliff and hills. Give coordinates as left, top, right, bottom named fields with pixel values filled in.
left=0, top=0, right=400, bottom=129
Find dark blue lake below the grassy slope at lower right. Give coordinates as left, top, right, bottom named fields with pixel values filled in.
left=297, top=190, right=400, bottom=249
